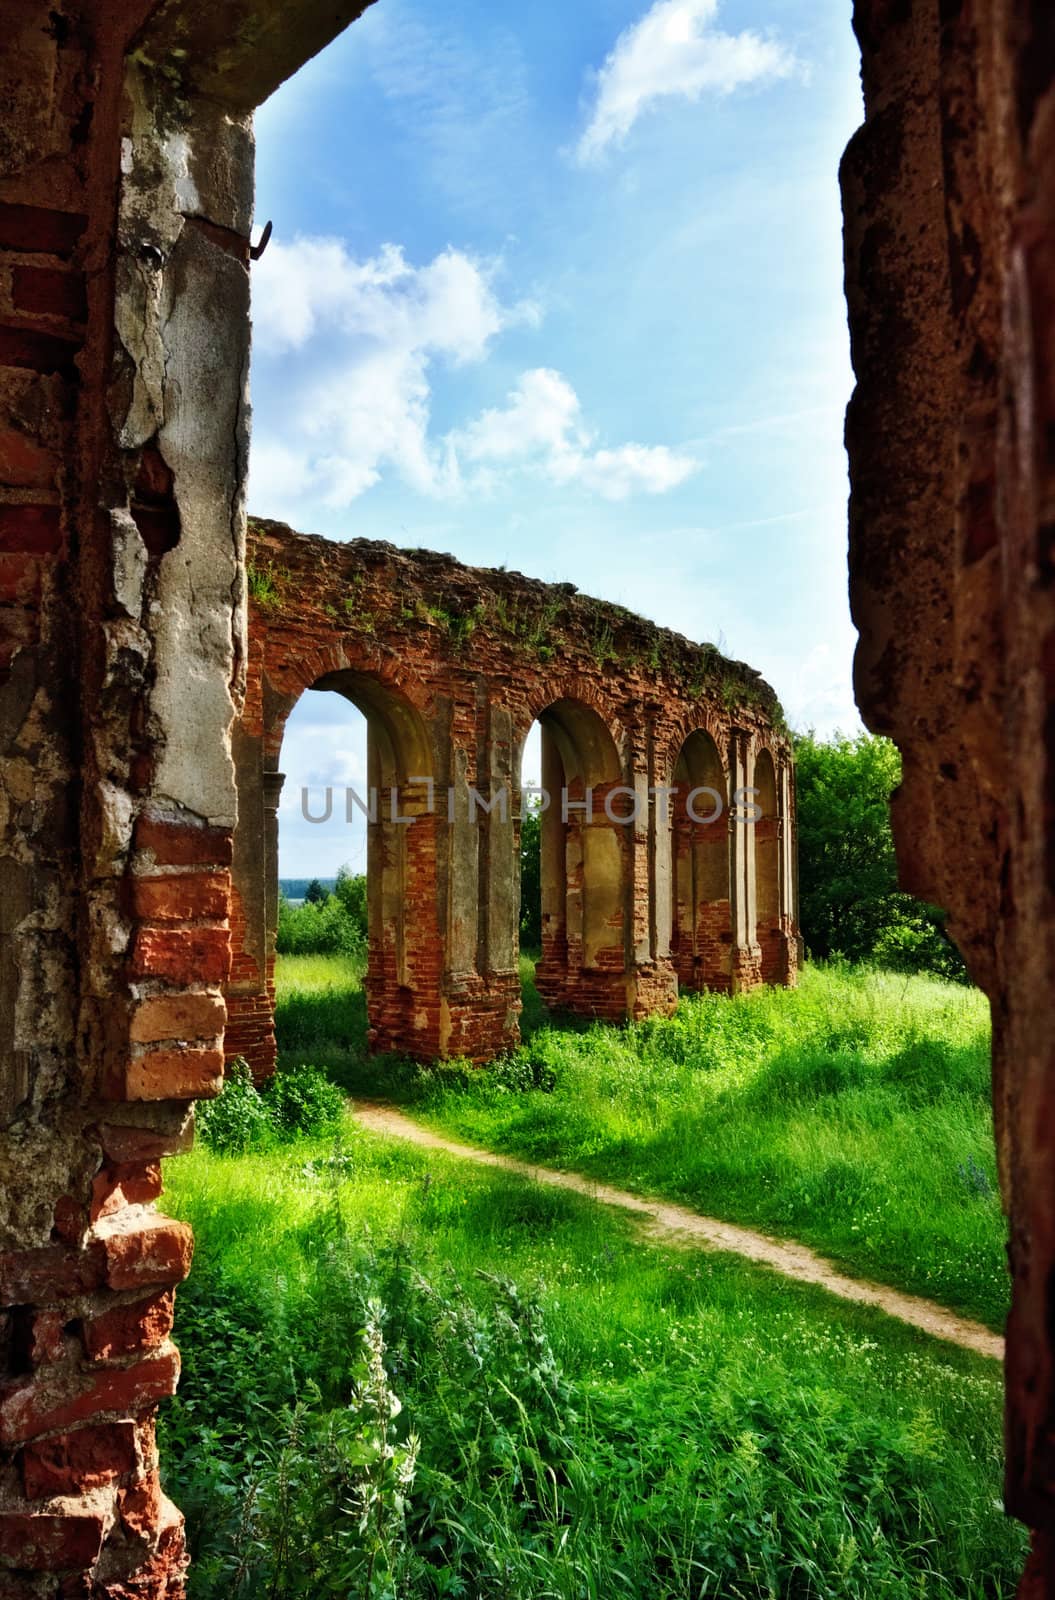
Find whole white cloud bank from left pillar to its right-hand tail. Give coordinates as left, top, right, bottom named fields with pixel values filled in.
left=251, top=238, right=696, bottom=517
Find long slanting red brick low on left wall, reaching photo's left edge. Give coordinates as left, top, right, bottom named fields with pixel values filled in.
left=0, top=1346, right=179, bottom=1446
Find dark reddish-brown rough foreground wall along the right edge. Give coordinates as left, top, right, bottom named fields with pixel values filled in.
left=842, top=0, right=1055, bottom=1597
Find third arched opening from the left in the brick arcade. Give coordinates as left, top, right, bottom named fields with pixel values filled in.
left=671, top=728, right=733, bottom=990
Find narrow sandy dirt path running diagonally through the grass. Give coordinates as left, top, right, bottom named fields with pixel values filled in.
left=352, top=1101, right=1004, bottom=1362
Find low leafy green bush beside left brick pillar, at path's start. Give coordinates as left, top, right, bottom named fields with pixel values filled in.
left=197, top=1058, right=344, bottom=1155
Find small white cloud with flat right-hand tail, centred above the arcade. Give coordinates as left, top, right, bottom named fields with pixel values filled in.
left=451, top=366, right=698, bottom=501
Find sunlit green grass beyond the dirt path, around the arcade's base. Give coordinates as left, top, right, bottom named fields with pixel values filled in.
left=277, top=958, right=1009, bottom=1328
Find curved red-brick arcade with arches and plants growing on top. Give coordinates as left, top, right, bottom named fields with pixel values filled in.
left=227, top=518, right=799, bottom=1077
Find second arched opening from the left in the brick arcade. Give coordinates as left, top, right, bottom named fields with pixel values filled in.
left=535, top=699, right=632, bottom=1016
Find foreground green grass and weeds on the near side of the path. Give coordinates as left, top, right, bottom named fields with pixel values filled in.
left=162, top=1113, right=1025, bottom=1600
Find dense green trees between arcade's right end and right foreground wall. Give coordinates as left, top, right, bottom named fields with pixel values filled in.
left=796, top=733, right=965, bottom=979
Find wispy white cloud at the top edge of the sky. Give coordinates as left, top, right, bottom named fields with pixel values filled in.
left=578, top=0, right=802, bottom=162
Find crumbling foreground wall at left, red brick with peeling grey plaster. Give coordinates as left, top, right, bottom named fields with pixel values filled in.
left=0, top=0, right=366, bottom=1600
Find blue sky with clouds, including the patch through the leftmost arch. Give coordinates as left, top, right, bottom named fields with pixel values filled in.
left=250, top=0, right=861, bottom=875
